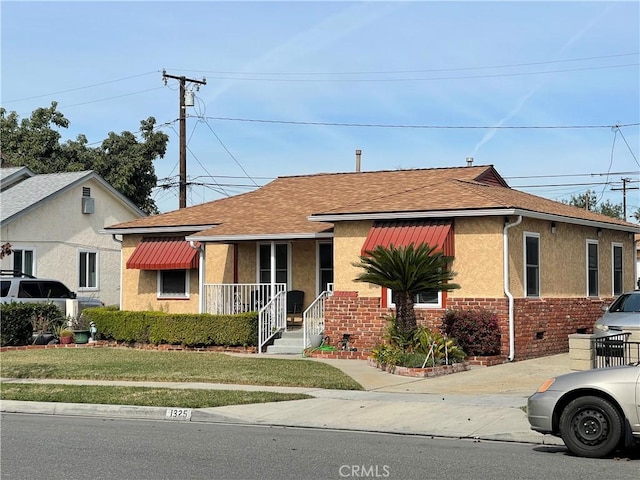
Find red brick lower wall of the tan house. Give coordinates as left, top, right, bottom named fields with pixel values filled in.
left=324, top=291, right=611, bottom=360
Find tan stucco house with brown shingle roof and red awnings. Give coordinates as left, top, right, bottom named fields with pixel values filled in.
left=105, top=166, right=640, bottom=359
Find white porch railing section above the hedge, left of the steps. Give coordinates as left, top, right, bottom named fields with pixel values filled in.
left=202, top=283, right=286, bottom=315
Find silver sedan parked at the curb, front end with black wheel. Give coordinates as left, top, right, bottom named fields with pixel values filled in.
left=527, top=363, right=640, bottom=457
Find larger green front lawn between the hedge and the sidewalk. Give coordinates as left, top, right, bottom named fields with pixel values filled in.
left=0, top=348, right=362, bottom=390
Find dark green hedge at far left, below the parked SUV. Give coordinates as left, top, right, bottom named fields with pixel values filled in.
left=0, top=302, right=64, bottom=347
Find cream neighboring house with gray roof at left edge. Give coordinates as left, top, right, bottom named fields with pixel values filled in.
left=0, top=167, right=145, bottom=305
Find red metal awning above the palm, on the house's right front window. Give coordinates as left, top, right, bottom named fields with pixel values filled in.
left=361, top=220, right=454, bottom=256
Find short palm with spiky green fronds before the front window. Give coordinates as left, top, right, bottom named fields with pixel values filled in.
left=353, top=243, right=460, bottom=333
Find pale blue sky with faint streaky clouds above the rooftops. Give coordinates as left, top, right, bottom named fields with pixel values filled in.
left=0, top=0, right=640, bottom=220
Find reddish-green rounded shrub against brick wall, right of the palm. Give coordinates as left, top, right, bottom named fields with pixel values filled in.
left=442, top=310, right=501, bottom=355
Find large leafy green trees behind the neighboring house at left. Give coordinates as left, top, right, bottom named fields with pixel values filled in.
left=0, top=102, right=169, bottom=214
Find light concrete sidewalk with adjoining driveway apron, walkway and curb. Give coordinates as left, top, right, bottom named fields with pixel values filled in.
left=0, top=354, right=570, bottom=445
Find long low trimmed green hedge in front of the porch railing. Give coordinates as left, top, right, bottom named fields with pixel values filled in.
left=82, top=307, right=258, bottom=347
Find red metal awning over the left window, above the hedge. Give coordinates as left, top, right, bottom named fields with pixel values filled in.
left=127, top=237, right=199, bottom=270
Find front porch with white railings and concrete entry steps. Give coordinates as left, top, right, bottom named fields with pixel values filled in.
left=200, top=283, right=331, bottom=354
